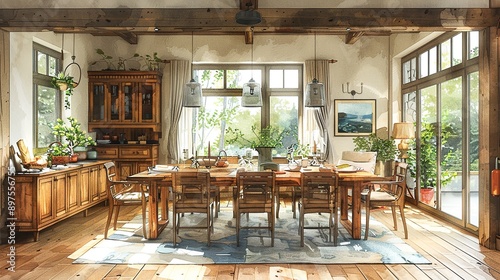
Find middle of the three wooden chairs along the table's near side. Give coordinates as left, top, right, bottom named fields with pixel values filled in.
left=235, top=171, right=276, bottom=247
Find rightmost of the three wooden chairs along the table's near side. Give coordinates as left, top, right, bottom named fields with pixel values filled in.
left=298, top=171, right=339, bottom=247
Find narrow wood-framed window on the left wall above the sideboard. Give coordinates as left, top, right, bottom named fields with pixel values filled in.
left=33, top=43, right=61, bottom=148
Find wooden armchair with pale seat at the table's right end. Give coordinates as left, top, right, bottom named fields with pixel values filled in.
left=361, top=162, right=408, bottom=239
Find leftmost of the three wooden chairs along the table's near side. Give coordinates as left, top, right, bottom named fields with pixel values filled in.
left=172, top=170, right=215, bottom=246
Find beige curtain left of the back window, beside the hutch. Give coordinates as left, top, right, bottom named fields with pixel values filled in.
left=166, top=60, right=191, bottom=163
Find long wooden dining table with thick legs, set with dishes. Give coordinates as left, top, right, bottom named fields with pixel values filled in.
left=128, top=164, right=387, bottom=239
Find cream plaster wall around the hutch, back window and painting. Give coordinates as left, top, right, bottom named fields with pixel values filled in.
left=11, top=32, right=390, bottom=163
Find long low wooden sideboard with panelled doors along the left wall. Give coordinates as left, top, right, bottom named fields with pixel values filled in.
left=15, top=160, right=108, bottom=241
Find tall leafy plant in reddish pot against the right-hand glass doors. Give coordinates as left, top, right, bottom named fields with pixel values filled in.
left=408, top=123, right=457, bottom=204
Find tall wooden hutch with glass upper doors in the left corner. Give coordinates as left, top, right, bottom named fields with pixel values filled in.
left=85, top=71, right=162, bottom=180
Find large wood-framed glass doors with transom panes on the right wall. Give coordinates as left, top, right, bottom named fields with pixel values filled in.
left=401, top=31, right=479, bottom=230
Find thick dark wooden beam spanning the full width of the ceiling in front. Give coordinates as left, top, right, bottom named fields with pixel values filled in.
left=0, top=8, right=500, bottom=36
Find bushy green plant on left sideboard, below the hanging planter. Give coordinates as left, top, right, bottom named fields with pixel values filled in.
left=52, top=117, right=96, bottom=162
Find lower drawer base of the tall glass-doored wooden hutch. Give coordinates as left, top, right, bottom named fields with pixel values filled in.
left=95, top=144, right=159, bottom=180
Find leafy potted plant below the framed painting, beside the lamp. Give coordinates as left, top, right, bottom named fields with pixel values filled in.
left=353, top=133, right=399, bottom=176
